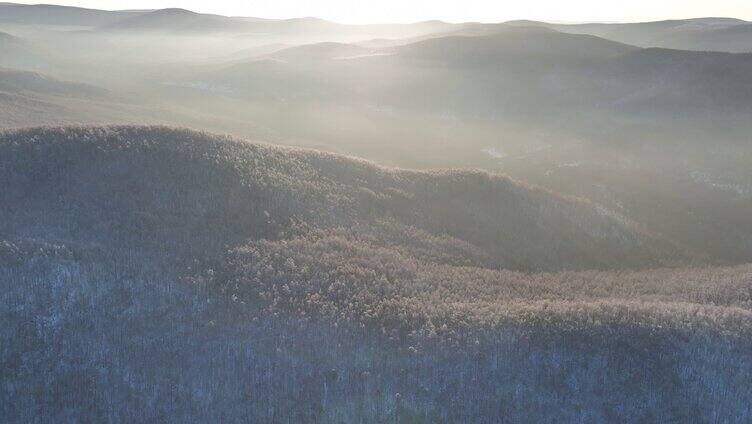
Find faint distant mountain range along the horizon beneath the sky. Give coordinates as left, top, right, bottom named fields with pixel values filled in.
left=0, top=3, right=752, bottom=53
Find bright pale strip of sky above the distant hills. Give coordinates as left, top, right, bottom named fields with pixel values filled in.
left=9, top=0, right=752, bottom=23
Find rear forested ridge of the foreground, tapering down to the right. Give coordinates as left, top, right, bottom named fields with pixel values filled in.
left=0, top=127, right=682, bottom=270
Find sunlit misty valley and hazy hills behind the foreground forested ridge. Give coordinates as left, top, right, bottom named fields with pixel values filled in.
left=2, top=6, right=752, bottom=263
